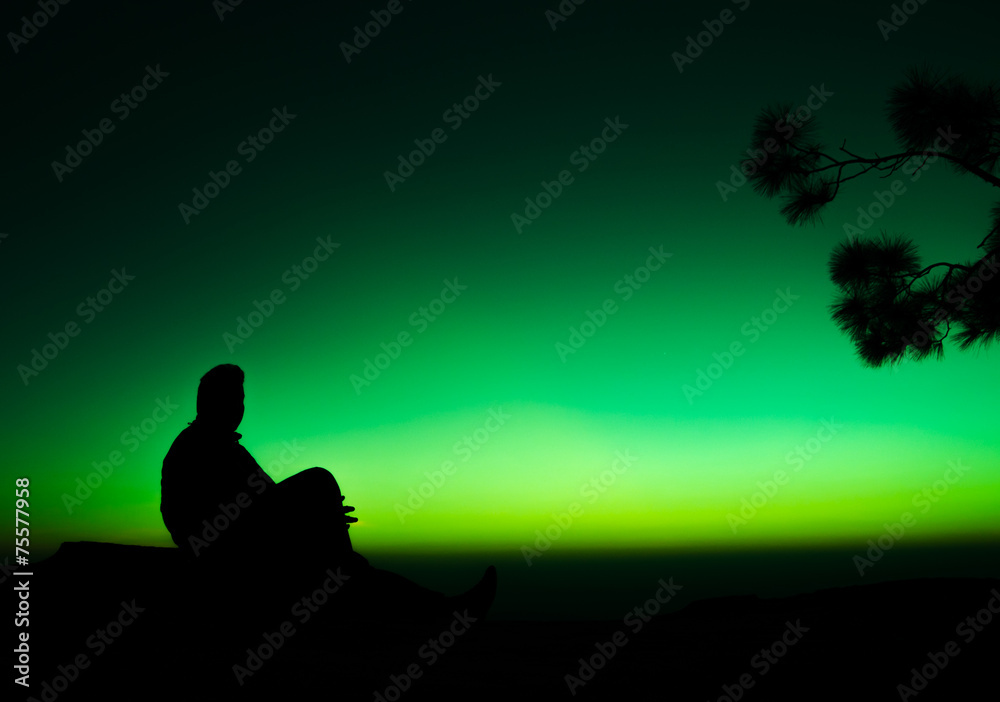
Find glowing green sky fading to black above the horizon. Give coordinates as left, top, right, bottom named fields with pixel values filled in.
left=0, top=0, right=1000, bottom=592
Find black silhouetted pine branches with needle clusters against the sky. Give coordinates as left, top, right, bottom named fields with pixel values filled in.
left=741, top=68, right=1000, bottom=368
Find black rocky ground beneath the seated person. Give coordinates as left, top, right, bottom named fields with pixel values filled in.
left=5, top=542, right=1000, bottom=702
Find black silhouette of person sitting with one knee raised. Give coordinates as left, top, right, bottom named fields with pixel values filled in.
left=160, top=364, right=496, bottom=628
